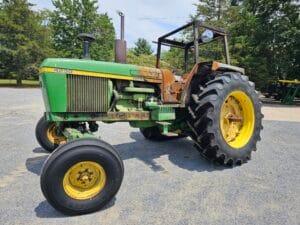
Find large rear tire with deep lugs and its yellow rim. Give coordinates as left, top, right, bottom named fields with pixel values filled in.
left=187, top=72, right=263, bottom=166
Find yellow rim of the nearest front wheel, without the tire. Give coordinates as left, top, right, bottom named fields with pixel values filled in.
left=63, top=161, right=106, bottom=200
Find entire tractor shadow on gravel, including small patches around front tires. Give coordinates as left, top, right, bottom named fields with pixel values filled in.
left=26, top=132, right=227, bottom=218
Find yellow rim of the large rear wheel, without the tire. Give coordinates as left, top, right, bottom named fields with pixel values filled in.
left=220, top=91, right=255, bottom=149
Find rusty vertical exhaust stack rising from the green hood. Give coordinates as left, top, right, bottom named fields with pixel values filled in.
left=115, top=11, right=127, bottom=63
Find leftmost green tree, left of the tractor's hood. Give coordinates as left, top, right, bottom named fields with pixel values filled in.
left=0, top=0, right=54, bottom=86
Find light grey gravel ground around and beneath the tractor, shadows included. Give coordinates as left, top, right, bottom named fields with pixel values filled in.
left=0, top=88, right=300, bottom=225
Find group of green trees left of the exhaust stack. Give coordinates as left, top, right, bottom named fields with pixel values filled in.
left=0, top=0, right=115, bottom=85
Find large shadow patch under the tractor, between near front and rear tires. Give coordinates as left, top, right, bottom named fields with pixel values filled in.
left=114, top=132, right=228, bottom=172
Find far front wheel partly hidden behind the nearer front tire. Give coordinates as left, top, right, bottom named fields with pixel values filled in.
left=35, top=116, right=67, bottom=152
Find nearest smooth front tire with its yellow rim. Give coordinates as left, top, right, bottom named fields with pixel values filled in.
left=41, top=138, right=124, bottom=215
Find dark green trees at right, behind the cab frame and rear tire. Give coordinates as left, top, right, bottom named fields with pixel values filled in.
left=193, top=0, right=300, bottom=87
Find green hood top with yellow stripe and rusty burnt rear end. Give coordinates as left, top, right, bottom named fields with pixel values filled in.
left=40, top=58, right=162, bottom=83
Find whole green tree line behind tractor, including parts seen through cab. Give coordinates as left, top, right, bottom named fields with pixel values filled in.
left=0, top=0, right=300, bottom=86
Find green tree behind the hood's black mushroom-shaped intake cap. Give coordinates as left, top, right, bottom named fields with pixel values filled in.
left=51, top=0, right=115, bottom=61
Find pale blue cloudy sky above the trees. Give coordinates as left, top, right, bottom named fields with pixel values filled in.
left=29, top=0, right=198, bottom=49
